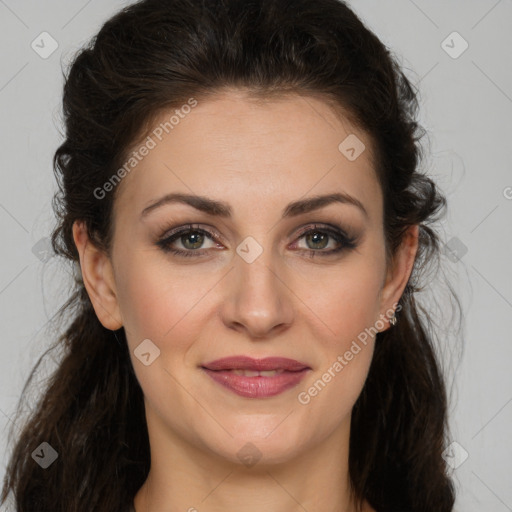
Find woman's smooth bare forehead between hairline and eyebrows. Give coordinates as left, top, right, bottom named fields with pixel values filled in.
left=115, top=91, right=381, bottom=224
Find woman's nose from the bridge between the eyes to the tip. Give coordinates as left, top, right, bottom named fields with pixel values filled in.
left=224, top=236, right=292, bottom=337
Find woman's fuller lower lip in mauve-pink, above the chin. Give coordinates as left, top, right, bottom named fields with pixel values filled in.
left=203, top=368, right=309, bottom=398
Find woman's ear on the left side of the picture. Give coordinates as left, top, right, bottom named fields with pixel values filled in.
left=73, top=221, right=123, bottom=331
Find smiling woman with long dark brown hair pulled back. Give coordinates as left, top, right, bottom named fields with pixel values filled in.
left=3, top=0, right=454, bottom=512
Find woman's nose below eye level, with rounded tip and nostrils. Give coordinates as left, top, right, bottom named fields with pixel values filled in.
left=221, top=247, right=294, bottom=339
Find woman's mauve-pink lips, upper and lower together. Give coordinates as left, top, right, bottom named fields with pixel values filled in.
left=201, top=356, right=311, bottom=398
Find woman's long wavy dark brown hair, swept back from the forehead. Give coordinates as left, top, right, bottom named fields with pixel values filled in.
left=2, top=0, right=454, bottom=512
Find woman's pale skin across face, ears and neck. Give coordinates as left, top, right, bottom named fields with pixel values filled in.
left=73, top=90, right=418, bottom=512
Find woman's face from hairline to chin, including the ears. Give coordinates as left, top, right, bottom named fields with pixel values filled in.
left=75, top=91, right=414, bottom=463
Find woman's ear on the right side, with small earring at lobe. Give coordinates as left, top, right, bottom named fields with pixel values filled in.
left=380, top=224, right=419, bottom=331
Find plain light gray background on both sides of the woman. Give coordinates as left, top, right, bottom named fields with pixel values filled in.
left=0, top=0, right=512, bottom=512
